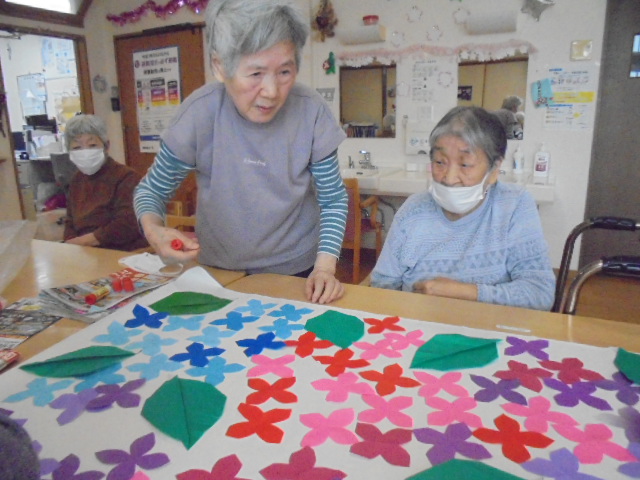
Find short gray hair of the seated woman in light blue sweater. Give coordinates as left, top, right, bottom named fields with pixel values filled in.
left=429, top=107, right=507, bottom=168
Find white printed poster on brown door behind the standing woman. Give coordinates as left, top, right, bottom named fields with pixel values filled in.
left=133, top=47, right=182, bottom=153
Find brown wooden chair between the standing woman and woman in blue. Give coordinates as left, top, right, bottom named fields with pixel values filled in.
left=342, top=178, right=382, bottom=284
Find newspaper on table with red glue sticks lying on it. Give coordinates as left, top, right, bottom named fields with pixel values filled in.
left=38, top=268, right=173, bottom=323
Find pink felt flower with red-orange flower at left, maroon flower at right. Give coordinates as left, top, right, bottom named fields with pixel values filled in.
left=300, top=408, right=358, bottom=447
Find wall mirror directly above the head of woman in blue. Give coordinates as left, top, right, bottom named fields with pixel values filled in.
left=458, top=55, right=529, bottom=139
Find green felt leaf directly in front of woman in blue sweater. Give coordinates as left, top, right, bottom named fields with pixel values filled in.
left=411, top=334, right=500, bottom=371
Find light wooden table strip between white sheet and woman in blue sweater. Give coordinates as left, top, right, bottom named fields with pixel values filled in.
left=227, top=274, right=640, bottom=352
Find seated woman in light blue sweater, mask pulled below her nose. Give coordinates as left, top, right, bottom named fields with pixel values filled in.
left=371, top=107, right=555, bottom=310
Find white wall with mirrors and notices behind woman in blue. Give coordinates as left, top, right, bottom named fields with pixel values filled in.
left=304, top=0, right=606, bottom=268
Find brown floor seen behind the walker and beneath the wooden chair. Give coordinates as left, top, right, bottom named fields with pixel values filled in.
left=336, top=249, right=640, bottom=323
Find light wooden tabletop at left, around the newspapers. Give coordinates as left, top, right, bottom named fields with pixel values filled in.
left=1, top=240, right=245, bottom=360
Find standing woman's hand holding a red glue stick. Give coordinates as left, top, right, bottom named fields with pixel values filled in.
left=140, top=213, right=200, bottom=263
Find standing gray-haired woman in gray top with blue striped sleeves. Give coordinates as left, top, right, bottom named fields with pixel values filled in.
left=135, top=0, right=347, bottom=303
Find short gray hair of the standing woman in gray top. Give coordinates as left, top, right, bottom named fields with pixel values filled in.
left=205, top=0, right=309, bottom=77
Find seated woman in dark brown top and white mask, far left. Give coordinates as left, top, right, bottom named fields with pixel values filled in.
left=64, top=115, right=148, bottom=251
